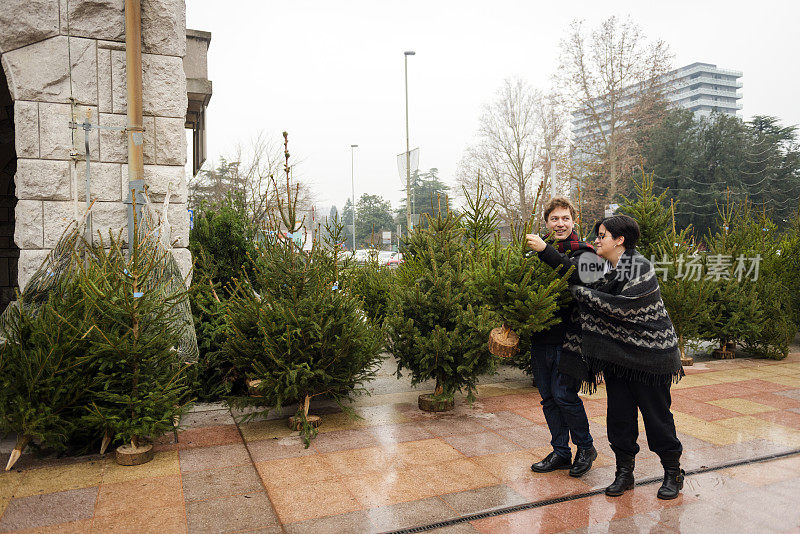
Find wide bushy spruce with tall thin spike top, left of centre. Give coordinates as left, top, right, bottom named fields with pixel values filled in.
left=225, top=133, right=382, bottom=446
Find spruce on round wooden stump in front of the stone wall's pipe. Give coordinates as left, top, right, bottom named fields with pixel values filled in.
left=77, top=228, right=191, bottom=449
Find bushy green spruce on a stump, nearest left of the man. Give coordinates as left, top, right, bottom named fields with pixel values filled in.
left=385, top=210, right=496, bottom=404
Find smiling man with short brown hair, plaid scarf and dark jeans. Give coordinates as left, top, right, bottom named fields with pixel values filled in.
left=527, top=197, right=597, bottom=477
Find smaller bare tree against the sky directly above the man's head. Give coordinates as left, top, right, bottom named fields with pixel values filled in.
left=458, top=79, right=544, bottom=226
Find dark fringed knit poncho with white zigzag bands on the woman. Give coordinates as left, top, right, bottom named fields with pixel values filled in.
left=563, top=250, right=683, bottom=392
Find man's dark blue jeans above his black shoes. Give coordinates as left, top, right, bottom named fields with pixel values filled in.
left=532, top=345, right=593, bottom=458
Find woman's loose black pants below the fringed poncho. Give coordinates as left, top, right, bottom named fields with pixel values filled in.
left=604, top=371, right=683, bottom=467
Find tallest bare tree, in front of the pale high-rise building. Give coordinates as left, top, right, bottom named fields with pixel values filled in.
left=556, top=17, right=672, bottom=211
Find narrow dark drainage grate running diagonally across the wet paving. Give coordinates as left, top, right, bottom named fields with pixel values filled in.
left=385, top=449, right=800, bottom=534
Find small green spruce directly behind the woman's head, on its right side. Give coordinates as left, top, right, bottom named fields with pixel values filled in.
left=619, top=170, right=671, bottom=259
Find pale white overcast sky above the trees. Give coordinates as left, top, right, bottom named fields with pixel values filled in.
left=186, top=0, right=800, bottom=216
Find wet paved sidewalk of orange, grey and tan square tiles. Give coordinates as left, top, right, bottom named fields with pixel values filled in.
left=0, top=353, right=800, bottom=533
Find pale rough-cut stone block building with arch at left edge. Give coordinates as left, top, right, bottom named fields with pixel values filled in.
left=0, top=0, right=211, bottom=309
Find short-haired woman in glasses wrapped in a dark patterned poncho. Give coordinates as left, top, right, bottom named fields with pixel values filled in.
left=528, top=215, right=684, bottom=499
